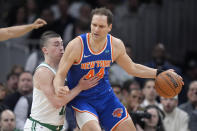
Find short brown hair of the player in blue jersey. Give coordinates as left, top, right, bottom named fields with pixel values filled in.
left=91, top=7, right=113, bottom=25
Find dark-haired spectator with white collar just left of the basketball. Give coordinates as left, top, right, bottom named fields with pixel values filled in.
left=141, top=79, right=161, bottom=107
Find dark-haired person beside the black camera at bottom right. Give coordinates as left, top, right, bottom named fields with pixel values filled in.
left=136, top=105, right=165, bottom=131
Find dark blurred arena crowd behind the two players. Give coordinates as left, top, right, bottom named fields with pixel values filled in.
left=0, top=0, right=197, bottom=131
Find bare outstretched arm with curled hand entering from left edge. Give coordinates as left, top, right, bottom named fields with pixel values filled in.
left=0, top=18, right=47, bottom=41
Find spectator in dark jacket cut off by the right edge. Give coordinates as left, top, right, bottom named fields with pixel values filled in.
left=179, top=80, right=197, bottom=131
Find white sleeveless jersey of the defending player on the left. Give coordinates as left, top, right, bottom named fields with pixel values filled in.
left=30, top=63, right=65, bottom=125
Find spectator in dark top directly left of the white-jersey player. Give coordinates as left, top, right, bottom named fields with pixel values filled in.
left=3, top=71, right=33, bottom=111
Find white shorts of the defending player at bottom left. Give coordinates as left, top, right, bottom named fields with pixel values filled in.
left=24, top=119, right=64, bottom=131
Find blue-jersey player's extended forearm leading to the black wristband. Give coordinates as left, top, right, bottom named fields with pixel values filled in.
left=130, top=64, right=157, bottom=78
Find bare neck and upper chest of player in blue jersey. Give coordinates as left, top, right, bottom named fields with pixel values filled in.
left=89, top=34, right=107, bottom=52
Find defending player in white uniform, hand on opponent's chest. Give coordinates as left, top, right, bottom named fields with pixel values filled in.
left=24, top=31, right=99, bottom=131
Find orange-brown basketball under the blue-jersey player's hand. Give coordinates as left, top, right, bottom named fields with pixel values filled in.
left=155, top=71, right=182, bottom=98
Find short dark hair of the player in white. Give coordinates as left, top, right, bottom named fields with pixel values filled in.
left=40, top=31, right=61, bottom=49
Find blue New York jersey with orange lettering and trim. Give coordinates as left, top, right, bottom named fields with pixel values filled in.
left=67, top=34, right=112, bottom=97
